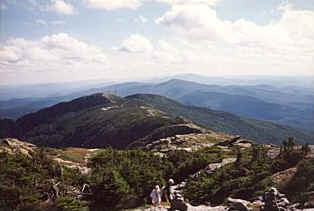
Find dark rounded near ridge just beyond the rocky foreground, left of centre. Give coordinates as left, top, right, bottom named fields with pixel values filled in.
left=16, top=94, right=201, bottom=148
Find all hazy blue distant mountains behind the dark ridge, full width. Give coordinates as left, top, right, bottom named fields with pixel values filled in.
left=0, top=75, right=314, bottom=132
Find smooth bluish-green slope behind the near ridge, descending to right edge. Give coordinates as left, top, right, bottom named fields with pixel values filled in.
left=126, top=94, right=313, bottom=144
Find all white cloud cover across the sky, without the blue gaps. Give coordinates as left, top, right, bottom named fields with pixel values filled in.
left=0, top=0, right=314, bottom=85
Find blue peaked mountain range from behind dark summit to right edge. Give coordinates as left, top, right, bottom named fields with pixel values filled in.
left=81, top=79, right=314, bottom=131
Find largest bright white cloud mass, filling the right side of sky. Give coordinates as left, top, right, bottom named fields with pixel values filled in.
left=155, top=4, right=314, bottom=74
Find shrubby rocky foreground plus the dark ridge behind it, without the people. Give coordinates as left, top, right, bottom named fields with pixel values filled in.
left=0, top=94, right=314, bottom=211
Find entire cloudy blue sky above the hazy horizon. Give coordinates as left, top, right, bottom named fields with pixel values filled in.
left=0, top=0, right=314, bottom=85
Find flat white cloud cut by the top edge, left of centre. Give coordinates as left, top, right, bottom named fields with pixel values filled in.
left=85, top=0, right=142, bottom=10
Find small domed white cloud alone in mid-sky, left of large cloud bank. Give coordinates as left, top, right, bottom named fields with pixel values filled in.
left=117, top=34, right=154, bottom=53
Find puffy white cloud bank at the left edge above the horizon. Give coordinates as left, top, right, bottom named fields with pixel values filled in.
left=0, top=33, right=107, bottom=71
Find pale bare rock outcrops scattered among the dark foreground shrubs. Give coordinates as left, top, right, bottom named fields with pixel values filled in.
left=0, top=131, right=314, bottom=211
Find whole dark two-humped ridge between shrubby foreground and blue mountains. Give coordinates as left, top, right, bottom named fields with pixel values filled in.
left=0, top=93, right=313, bottom=148
